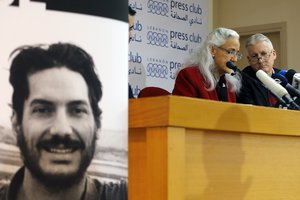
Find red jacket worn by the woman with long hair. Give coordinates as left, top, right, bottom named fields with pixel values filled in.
left=172, top=66, right=236, bottom=103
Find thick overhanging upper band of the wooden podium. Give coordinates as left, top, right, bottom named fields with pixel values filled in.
left=129, top=95, right=300, bottom=136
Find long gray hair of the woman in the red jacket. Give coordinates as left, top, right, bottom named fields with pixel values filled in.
left=185, top=28, right=240, bottom=91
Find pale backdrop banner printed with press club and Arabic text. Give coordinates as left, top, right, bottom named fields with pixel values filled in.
left=128, top=0, right=209, bottom=96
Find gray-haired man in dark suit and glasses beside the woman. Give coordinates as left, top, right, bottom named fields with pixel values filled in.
left=237, top=33, right=280, bottom=106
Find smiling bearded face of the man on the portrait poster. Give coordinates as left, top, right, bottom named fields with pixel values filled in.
left=18, top=67, right=97, bottom=188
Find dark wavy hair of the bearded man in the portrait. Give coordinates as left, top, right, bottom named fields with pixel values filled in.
left=9, top=43, right=102, bottom=128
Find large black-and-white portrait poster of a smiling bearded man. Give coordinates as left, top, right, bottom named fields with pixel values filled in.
left=0, top=0, right=128, bottom=199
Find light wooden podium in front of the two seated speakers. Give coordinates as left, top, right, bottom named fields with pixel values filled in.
left=129, top=96, right=300, bottom=200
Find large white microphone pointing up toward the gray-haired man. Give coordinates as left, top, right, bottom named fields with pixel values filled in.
left=256, top=69, right=300, bottom=110
